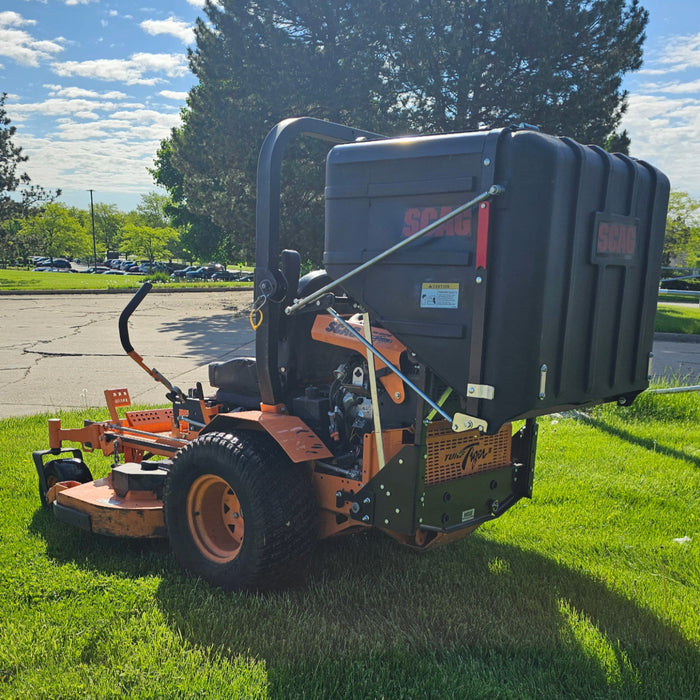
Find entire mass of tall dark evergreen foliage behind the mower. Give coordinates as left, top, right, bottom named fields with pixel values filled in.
left=154, top=0, right=647, bottom=258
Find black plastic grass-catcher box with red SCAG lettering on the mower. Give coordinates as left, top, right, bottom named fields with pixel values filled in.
left=324, top=129, right=669, bottom=432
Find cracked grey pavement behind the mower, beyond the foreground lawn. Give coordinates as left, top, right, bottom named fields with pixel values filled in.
left=0, top=291, right=700, bottom=418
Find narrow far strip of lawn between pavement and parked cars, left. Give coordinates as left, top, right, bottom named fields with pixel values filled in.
left=0, top=270, right=251, bottom=292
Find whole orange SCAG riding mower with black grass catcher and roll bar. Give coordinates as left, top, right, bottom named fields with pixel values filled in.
left=34, top=118, right=669, bottom=590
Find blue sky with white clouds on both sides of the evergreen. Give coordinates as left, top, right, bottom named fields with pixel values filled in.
left=0, top=0, right=700, bottom=210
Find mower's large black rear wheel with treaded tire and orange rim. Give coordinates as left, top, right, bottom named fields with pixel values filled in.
left=163, top=431, right=316, bottom=591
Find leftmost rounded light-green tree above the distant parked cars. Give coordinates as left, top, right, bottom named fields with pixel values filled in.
left=21, top=203, right=92, bottom=258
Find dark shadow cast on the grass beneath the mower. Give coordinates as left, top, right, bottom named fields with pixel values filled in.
left=28, top=513, right=700, bottom=698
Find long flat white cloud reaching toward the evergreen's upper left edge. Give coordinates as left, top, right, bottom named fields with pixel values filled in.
left=51, top=53, right=187, bottom=85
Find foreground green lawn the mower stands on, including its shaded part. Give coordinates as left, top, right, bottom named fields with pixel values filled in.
left=0, top=394, right=700, bottom=699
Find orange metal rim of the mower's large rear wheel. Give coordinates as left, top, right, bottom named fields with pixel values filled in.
left=187, top=474, right=245, bottom=564
